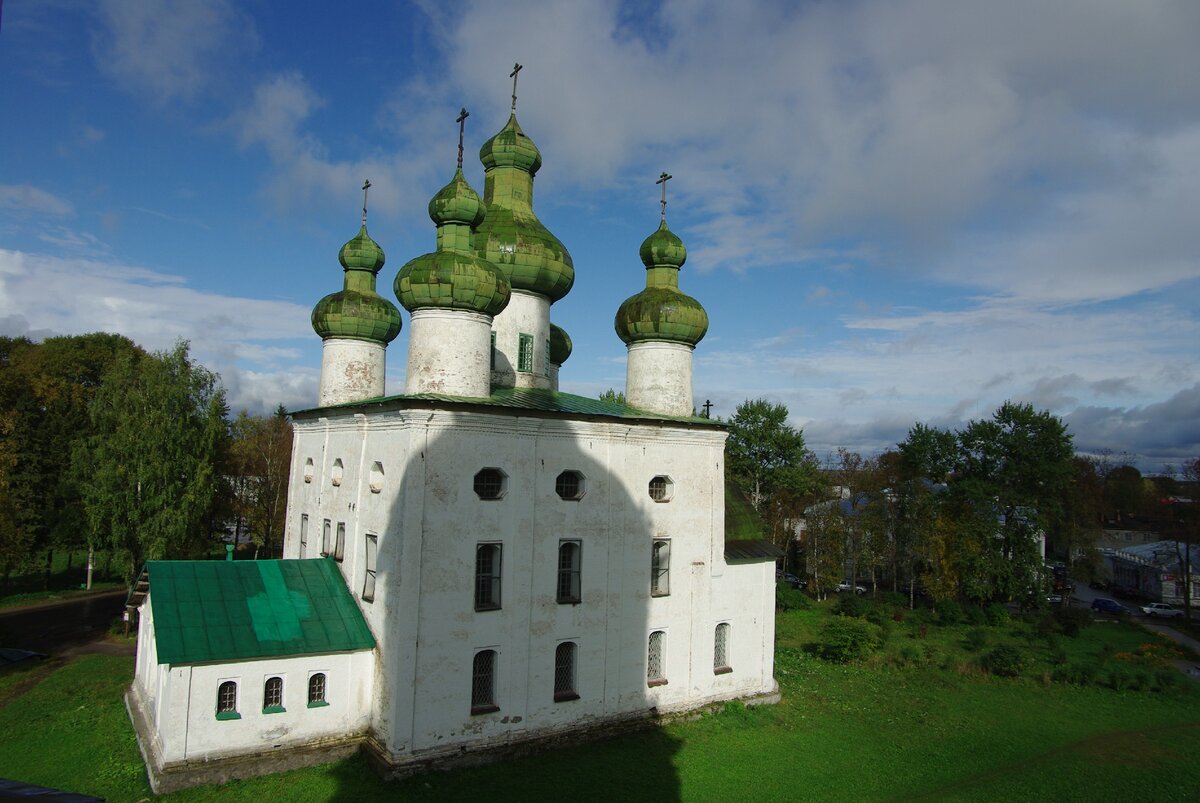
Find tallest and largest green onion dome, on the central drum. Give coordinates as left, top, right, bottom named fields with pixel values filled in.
left=475, top=114, right=575, bottom=302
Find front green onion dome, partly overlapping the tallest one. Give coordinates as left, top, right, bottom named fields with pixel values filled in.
left=394, top=168, right=510, bottom=316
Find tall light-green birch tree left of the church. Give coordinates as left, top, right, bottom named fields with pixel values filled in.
left=76, top=341, right=226, bottom=582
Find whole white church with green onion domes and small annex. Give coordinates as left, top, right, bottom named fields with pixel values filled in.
left=126, top=97, right=780, bottom=792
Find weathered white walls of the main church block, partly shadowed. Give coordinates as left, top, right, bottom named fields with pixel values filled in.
left=284, top=401, right=775, bottom=765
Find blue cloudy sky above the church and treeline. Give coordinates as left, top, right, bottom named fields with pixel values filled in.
left=0, top=0, right=1200, bottom=472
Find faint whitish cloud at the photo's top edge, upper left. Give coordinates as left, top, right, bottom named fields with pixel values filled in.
left=92, top=0, right=257, bottom=102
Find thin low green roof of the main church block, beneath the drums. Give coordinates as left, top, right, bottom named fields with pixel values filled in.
left=292, top=388, right=725, bottom=429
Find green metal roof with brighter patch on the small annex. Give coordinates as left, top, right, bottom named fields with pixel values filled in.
left=145, top=558, right=376, bottom=664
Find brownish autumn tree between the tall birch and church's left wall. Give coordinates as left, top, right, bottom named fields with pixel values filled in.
left=228, top=405, right=292, bottom=556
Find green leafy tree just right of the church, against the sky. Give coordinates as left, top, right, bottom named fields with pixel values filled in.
left=725, top=398, right=820, bottom=513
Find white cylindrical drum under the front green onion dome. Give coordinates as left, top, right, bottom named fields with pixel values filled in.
left=404, top=308, right=492, bottom=397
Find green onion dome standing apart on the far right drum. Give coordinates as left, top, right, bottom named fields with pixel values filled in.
left=613, top=221, right=708, bottom=346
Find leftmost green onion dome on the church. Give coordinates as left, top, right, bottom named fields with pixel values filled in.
left=312, top=224, right=401, bottom=344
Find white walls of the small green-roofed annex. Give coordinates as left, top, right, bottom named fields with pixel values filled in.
left=132, top=587, right=376, bottom=769
